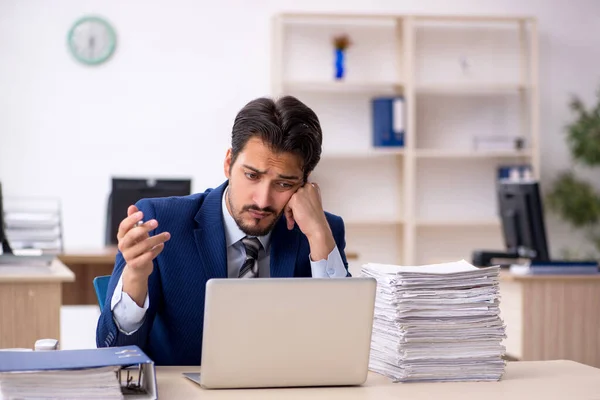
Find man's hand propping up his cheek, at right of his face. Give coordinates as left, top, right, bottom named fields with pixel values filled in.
left=285, top=182, right=335, bottom=261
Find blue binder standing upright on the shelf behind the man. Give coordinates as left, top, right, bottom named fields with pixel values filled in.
left=371, top=96, right=405, bottom=147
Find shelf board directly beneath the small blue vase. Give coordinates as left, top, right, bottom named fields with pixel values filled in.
left=283, top=81, right=403, bottom=94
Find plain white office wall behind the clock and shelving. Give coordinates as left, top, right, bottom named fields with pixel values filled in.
left=0, top=0, right=600, bottom=252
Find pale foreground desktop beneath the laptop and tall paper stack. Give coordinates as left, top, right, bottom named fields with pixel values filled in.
left=157, top=361, right=600, bottom=400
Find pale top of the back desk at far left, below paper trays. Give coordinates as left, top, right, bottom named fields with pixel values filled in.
left=0, top=260, right=75, bottom=283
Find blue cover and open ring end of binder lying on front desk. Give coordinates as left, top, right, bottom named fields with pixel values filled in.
left=0, top=346, right=158, bottom=399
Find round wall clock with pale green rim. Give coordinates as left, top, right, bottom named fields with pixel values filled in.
left=68, top=17, right=116, bottom=65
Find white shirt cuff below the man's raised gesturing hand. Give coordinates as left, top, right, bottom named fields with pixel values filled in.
left=110, top=276, right=150, bottom=335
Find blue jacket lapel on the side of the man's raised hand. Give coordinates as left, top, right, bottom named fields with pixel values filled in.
left=194, top=182, right=228, bottom=280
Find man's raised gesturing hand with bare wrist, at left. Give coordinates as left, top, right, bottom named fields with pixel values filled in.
left=117, top=206, right=171, bottom=307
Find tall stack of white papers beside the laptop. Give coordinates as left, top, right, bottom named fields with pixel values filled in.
left=361, top=260, right=505, bottom=382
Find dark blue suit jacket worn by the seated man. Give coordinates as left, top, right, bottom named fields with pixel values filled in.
left=96, top=182, right=349, bottom=365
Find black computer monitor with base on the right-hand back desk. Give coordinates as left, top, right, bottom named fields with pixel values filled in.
left=473, top=180, right=550, bottom=266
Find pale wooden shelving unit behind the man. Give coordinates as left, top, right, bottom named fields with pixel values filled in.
left=271, top=13, right=540, bottom=271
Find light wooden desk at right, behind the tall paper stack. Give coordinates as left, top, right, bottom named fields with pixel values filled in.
left=500, top=271, right=600, bottom=368
